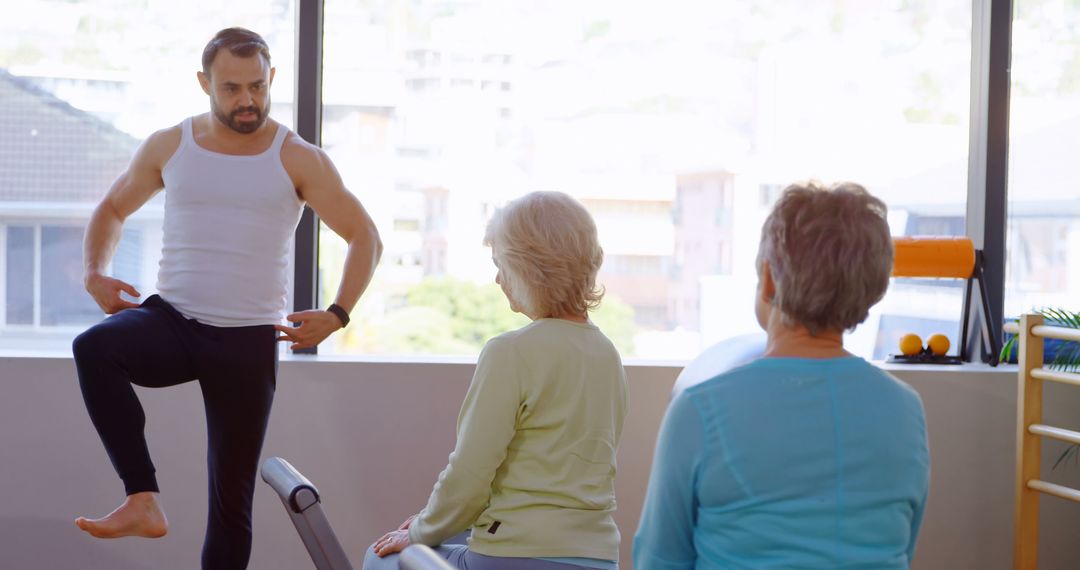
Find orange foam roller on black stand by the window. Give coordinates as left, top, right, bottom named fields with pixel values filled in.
left=892, top=235, right=975, bottom=279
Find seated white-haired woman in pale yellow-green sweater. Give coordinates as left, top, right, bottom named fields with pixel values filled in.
left=364, top=192, right=626, bottom=570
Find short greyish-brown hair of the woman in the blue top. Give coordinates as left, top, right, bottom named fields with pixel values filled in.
left=757, top=181, right=893, bottom=335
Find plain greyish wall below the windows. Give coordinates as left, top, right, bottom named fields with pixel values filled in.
left=0, top=357, right=1080, bottom=570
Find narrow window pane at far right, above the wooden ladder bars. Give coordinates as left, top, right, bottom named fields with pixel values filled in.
left=1004, top=0, right=1080, bottom=316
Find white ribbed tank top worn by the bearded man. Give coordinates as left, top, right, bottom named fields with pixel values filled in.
left=158, top=118, right=303, bottom=327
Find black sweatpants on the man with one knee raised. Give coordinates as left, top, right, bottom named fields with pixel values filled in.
left=72, top=295, right=278, bottom=570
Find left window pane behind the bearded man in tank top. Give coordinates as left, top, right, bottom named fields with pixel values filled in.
left=0, top=0, right=295, bottom=349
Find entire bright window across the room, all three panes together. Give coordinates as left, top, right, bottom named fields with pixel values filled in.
left=6, top=0, right=1080, bottom=358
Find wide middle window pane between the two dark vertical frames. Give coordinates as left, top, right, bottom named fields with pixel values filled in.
left=320, top=0, right=972, bottom=357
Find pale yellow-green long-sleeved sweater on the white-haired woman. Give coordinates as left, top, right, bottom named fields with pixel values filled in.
left=409, top=318, right=627, bottom=560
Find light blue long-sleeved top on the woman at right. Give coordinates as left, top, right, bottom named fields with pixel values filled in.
left=633, top=356, right=930, bottom=570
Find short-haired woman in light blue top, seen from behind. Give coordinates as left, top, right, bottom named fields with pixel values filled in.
left=634, top=184, right=930, bottom=570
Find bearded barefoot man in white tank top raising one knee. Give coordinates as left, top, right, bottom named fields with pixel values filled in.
left=72, top=28, right=382, bottom=569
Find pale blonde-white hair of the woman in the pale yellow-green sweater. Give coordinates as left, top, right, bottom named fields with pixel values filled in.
left=484, top=192, right=604, bottom=318
